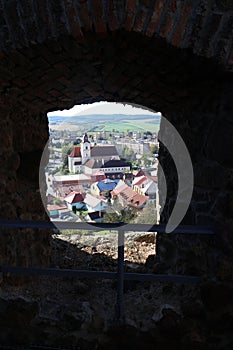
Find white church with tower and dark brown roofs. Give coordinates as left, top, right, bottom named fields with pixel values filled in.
left=68, top=134, right=130, bottom=174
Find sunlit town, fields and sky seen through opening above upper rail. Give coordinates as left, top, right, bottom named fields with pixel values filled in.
left=45, top=102, right=161, bottom=224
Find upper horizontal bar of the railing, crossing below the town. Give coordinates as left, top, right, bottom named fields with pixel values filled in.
left=0, top=220, right=215, bottom=235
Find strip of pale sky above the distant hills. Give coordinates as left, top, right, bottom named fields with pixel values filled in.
left=48, top=102, right=160, bottom=117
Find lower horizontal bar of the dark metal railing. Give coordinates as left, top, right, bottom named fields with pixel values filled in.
left=0, top=265, right=200, bottom=284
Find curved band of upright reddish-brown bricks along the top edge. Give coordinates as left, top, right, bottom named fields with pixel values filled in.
left=0, top=0, right=233, bottom=69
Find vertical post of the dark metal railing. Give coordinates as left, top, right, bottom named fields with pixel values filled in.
left=116, top=230, right=125, bottom=323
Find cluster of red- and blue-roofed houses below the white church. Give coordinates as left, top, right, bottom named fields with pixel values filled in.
left=48, top=171, right=157, bottom=223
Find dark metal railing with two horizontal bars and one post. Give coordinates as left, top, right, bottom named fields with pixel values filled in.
left=0, top=220, right=215, bottom=323
